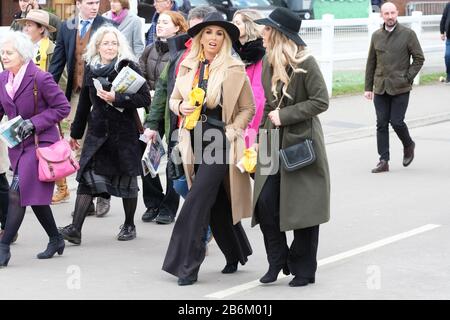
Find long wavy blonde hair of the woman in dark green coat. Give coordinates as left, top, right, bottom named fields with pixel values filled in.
left=266, top=26, right=311, bottom=100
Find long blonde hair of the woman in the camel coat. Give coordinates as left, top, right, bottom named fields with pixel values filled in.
left=186, top=27, right=244, bottom=108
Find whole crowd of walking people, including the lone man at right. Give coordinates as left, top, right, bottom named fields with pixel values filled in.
left=0, top=0, right=440, bottom=287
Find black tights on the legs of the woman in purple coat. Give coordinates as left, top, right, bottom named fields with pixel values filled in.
left=1, top=190, right=59, bottom=245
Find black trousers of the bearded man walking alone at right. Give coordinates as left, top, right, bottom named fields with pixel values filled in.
left=373, top=92, right=413, bottom=161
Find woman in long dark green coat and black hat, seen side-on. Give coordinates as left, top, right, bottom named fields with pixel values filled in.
left=252, top=8, right=330, bottom=287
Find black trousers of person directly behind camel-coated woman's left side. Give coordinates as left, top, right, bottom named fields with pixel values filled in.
left=142, top=126, right=180, bottom=217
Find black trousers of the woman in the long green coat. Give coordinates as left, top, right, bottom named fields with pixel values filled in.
left=256, top=172, right=319, bottom=278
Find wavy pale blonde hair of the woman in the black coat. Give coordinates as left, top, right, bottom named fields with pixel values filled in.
left=83, top=25, right=136, bottom=66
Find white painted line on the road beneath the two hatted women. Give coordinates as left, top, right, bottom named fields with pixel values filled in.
left=205, top=224, right=440, bottom=299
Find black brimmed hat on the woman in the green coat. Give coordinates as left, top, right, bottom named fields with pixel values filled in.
left=255, top=8, right=306, bottom=46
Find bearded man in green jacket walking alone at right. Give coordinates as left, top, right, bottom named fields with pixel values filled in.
left=364, top=2, right=425, bottom=173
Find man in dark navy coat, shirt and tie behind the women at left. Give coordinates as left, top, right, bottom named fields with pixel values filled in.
left=48, top=0, right=112, bottom=216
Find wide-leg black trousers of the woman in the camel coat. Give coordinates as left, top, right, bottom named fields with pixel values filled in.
left=162, top=124, right=252, bottom=278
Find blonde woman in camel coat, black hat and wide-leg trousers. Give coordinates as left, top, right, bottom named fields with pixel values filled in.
left=162, top=13, right=255, bottom=285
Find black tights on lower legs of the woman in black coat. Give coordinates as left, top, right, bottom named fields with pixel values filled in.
left=72, top=194, right=137, bottom=232
